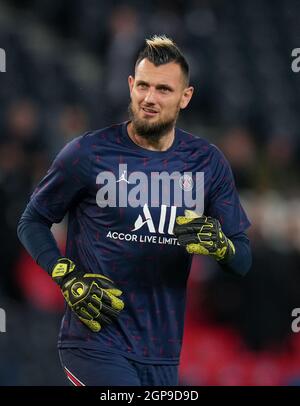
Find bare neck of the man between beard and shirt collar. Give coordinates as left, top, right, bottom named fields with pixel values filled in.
left=127, top=122, right=175, bottom=151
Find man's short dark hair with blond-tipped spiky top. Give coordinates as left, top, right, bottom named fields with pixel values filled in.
left=135, top=35, right=190, bottom=84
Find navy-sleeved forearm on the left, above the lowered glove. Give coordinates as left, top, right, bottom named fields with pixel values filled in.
left=17, top=203, right=62, bottom=274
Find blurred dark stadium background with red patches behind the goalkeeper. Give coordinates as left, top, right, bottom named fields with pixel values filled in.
left=0, top=0, right=300, bottom=385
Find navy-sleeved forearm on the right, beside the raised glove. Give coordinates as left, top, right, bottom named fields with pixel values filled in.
left=219, top=233, right=252, bottom=276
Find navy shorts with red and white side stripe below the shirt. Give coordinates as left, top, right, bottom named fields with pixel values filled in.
left=59, top=348, right=178, bottom=386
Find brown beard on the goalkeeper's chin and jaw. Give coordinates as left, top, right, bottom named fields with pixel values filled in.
left=128, top=103, right=179, bottom=140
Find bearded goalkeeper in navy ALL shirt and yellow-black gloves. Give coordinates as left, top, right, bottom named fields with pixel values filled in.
left=18, top=36, right=251, bottom=386
